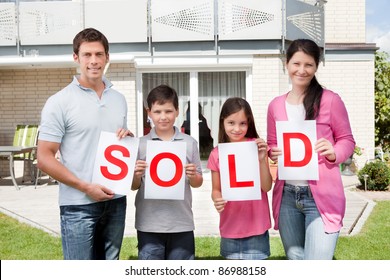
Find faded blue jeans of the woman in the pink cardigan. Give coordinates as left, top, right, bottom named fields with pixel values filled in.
left=279, top=184, right=339, bottom=260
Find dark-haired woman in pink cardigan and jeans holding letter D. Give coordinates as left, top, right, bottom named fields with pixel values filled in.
left=267, top=39, right=355, bottom=259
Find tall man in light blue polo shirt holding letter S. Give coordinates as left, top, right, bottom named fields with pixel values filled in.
left=38, top=28, right=133, bottom=259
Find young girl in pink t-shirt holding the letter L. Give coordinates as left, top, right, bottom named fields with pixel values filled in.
left=207, top=97, right=272, bottom=260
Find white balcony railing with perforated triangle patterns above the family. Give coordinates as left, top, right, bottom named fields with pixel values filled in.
left=0, top=0, right=326, bottom=49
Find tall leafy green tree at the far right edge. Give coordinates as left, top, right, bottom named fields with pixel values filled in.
left=375, top=52, right=390, bottom=151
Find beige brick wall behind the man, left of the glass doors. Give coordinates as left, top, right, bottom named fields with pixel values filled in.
left=0, top=64, right=136, bottom=176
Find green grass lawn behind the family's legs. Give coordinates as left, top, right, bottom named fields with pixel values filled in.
left=0, top=201, right=390, bottom=260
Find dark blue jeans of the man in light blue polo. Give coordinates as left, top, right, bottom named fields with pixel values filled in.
left=60, top=196, right=127, bottom=260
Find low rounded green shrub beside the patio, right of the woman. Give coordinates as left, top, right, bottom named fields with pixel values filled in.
left=358, top=160, right=390, bottom=191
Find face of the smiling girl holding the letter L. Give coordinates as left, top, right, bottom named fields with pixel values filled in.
left=223, top=109, right=248, bottom=142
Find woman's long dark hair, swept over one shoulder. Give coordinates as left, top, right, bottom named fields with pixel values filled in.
left=286, top=39, right=323, bottom=120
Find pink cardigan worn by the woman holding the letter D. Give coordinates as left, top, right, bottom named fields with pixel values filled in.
left=267, top=89, right=355, bottom=233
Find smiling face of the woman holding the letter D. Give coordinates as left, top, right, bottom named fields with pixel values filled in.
left=286, top=51, right=317, bottom=88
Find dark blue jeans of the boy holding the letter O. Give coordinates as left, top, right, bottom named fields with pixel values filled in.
left=137, top=230, right=195, bottom=260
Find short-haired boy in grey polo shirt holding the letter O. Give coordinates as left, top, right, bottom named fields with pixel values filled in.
left=131, top=85, right=203, bottom=260
